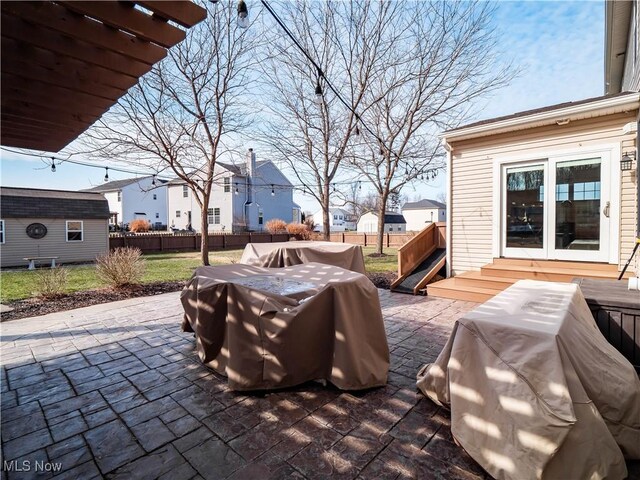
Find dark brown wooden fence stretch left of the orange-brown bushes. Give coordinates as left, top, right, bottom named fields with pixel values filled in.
left=109, top=233, right=293, bottom=253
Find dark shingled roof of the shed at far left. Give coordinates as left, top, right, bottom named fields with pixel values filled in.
left=0, top=187, right=109, bottom=218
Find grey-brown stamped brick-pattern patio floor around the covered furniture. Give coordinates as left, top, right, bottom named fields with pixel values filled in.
left=1, top=291, right=636, bottom=480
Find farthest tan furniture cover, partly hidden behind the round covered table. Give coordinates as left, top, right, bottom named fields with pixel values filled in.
left=240, top=241, right=365, bottom=274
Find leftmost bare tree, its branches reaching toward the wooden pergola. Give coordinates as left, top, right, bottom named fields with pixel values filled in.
left=75, top=0, right=256, bottom=265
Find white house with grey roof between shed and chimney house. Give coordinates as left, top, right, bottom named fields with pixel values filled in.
left=83, top=176, right=167, bottom=228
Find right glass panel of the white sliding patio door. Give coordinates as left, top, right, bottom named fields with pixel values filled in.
left=555, top=158, right=602, bottom=251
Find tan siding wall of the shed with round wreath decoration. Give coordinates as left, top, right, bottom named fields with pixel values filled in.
left=0, top=218, right=109, bottom=267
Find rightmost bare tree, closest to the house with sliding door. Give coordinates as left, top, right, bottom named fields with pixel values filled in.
left=352, top=1, right=515, bottom=253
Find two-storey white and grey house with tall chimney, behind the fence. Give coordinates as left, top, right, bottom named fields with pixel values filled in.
left=167, top=149, right=301, bottom=232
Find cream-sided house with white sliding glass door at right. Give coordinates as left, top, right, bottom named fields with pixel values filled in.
left=443, top=2, right=640, bottom=275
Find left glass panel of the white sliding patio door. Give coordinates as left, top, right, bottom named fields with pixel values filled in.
left=503, top=163, right=545, bottom=258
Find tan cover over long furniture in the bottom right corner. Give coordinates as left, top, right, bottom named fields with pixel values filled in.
left=417, top=280, right=640, bottom=480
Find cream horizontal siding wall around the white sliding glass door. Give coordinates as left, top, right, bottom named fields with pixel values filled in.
left=449, top=111, right=637, bottom=275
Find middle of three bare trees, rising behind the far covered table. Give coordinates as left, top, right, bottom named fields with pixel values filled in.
left=264, top=0, right=392, bottom=239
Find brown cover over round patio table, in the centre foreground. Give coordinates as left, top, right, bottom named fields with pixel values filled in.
left=181, top=263, right=389, bottom=390
